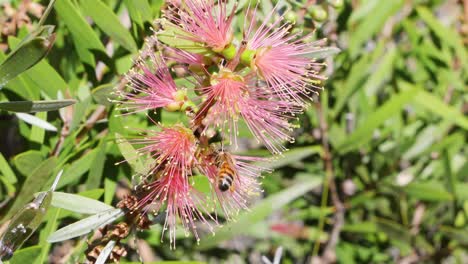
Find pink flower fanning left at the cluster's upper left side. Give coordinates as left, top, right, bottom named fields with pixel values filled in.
left=117, top=52, right=186, bottom=113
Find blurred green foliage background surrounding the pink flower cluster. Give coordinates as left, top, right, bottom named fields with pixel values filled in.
left=0, top=0, right=468, bottom=263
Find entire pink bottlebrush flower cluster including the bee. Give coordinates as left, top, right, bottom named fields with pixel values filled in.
left=118, top=0, right=330, bottom=246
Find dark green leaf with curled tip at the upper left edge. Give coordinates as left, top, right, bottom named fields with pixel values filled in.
left=0, top=26, right=55, bottom=89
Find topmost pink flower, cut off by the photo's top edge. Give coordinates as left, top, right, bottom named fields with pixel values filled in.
left=166, top=0, right=235, bottom=52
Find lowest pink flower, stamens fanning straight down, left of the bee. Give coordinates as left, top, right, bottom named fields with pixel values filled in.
left=138, top=166, right=217, bottom=248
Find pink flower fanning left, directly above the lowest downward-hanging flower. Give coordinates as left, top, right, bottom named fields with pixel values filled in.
left=131, top=125, right=197, bottom=177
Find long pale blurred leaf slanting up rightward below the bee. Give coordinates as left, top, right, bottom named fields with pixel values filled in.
left=199, top=177, right=321, bottom=250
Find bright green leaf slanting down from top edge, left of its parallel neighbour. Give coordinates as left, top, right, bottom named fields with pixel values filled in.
left=54, top=0, right=106, bottom=66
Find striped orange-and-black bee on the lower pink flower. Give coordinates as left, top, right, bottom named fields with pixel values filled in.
left=217, top=152, right=237, bottom=192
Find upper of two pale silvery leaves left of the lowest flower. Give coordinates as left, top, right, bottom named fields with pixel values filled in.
left=52, top=192, right=113, bottom=214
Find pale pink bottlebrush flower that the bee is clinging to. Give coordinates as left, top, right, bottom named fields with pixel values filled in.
left=199, top=151, right=269, bottom=220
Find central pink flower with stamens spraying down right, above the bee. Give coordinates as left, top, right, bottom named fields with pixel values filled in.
left=195, top=68, right=301, bottom=154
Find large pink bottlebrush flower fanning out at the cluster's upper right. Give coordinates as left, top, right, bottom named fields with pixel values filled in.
left=241, top=8, right=325, bottom=105
